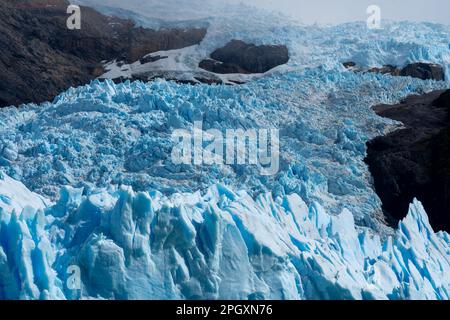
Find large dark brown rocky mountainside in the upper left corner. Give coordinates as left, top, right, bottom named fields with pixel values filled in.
left=0, top=0, right=206, bottom=107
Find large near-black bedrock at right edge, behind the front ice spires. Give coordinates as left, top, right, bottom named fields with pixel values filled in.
left=366, top=90, right=450, bottom=231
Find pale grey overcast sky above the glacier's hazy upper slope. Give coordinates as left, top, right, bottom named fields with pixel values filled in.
left=228, top=0, right=450, bottom=24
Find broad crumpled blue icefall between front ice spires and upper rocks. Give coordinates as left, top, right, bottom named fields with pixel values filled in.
left=0, top=67, right=446, bottom=229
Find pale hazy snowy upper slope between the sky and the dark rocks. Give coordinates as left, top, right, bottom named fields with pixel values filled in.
left=74, top=0, right=450, bottom=84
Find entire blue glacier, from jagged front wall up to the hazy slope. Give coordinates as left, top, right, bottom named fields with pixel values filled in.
left=0, top=23, right=450, bottom=299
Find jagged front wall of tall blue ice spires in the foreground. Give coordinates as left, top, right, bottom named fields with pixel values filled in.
left=0, top=174, right=450, bottom=299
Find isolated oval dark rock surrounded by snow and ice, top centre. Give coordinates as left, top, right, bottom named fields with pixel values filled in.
left=199, top=40, right=289, bottom=74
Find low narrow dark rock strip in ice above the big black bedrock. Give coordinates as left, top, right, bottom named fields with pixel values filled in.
left=343, top=61, right=445, bottom=81
